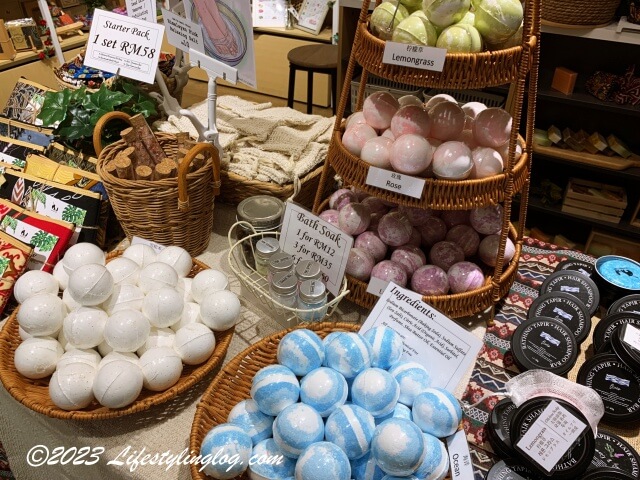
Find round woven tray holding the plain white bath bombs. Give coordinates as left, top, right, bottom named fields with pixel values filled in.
left=0, top=251, right=234, bottom=420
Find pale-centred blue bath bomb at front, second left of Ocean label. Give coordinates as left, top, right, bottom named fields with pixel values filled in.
left=371, top=418, right=425, bottom=477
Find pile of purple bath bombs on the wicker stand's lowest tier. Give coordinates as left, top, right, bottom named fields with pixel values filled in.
left=320, top=189, right=515, bottom=295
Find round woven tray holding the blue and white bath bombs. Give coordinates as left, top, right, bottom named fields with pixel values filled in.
left=189, top=322, right=360, bottom=480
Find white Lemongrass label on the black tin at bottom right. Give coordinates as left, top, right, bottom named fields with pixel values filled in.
left=517, top=400, right=587, bottom=472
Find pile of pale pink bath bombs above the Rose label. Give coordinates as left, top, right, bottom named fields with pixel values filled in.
left=342, top=92, right=522, bottom=180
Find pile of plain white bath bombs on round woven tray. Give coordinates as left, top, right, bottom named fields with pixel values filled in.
left=14, top=243, right=240, bottom=410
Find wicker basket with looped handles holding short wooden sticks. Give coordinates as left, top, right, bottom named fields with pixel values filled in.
left=93, top=112, right=220, bottom=257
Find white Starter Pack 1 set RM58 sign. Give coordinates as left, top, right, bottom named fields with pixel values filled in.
left=84, top=8, right=164, bottom=83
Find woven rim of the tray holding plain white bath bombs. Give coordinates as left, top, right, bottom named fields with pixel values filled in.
left=0, top=250, right=235, bottom=421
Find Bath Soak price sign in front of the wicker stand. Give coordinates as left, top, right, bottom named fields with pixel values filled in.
left=280, top=202, right=353, bottom=296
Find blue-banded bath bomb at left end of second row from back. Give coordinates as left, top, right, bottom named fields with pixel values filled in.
left=251, top=365, right=300, bottom=417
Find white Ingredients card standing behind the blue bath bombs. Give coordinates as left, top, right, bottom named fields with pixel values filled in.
left=360, top=282, right=482, bottom=393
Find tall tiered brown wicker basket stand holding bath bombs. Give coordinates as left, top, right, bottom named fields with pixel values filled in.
left=314, top=0, right=540, bottom=318
